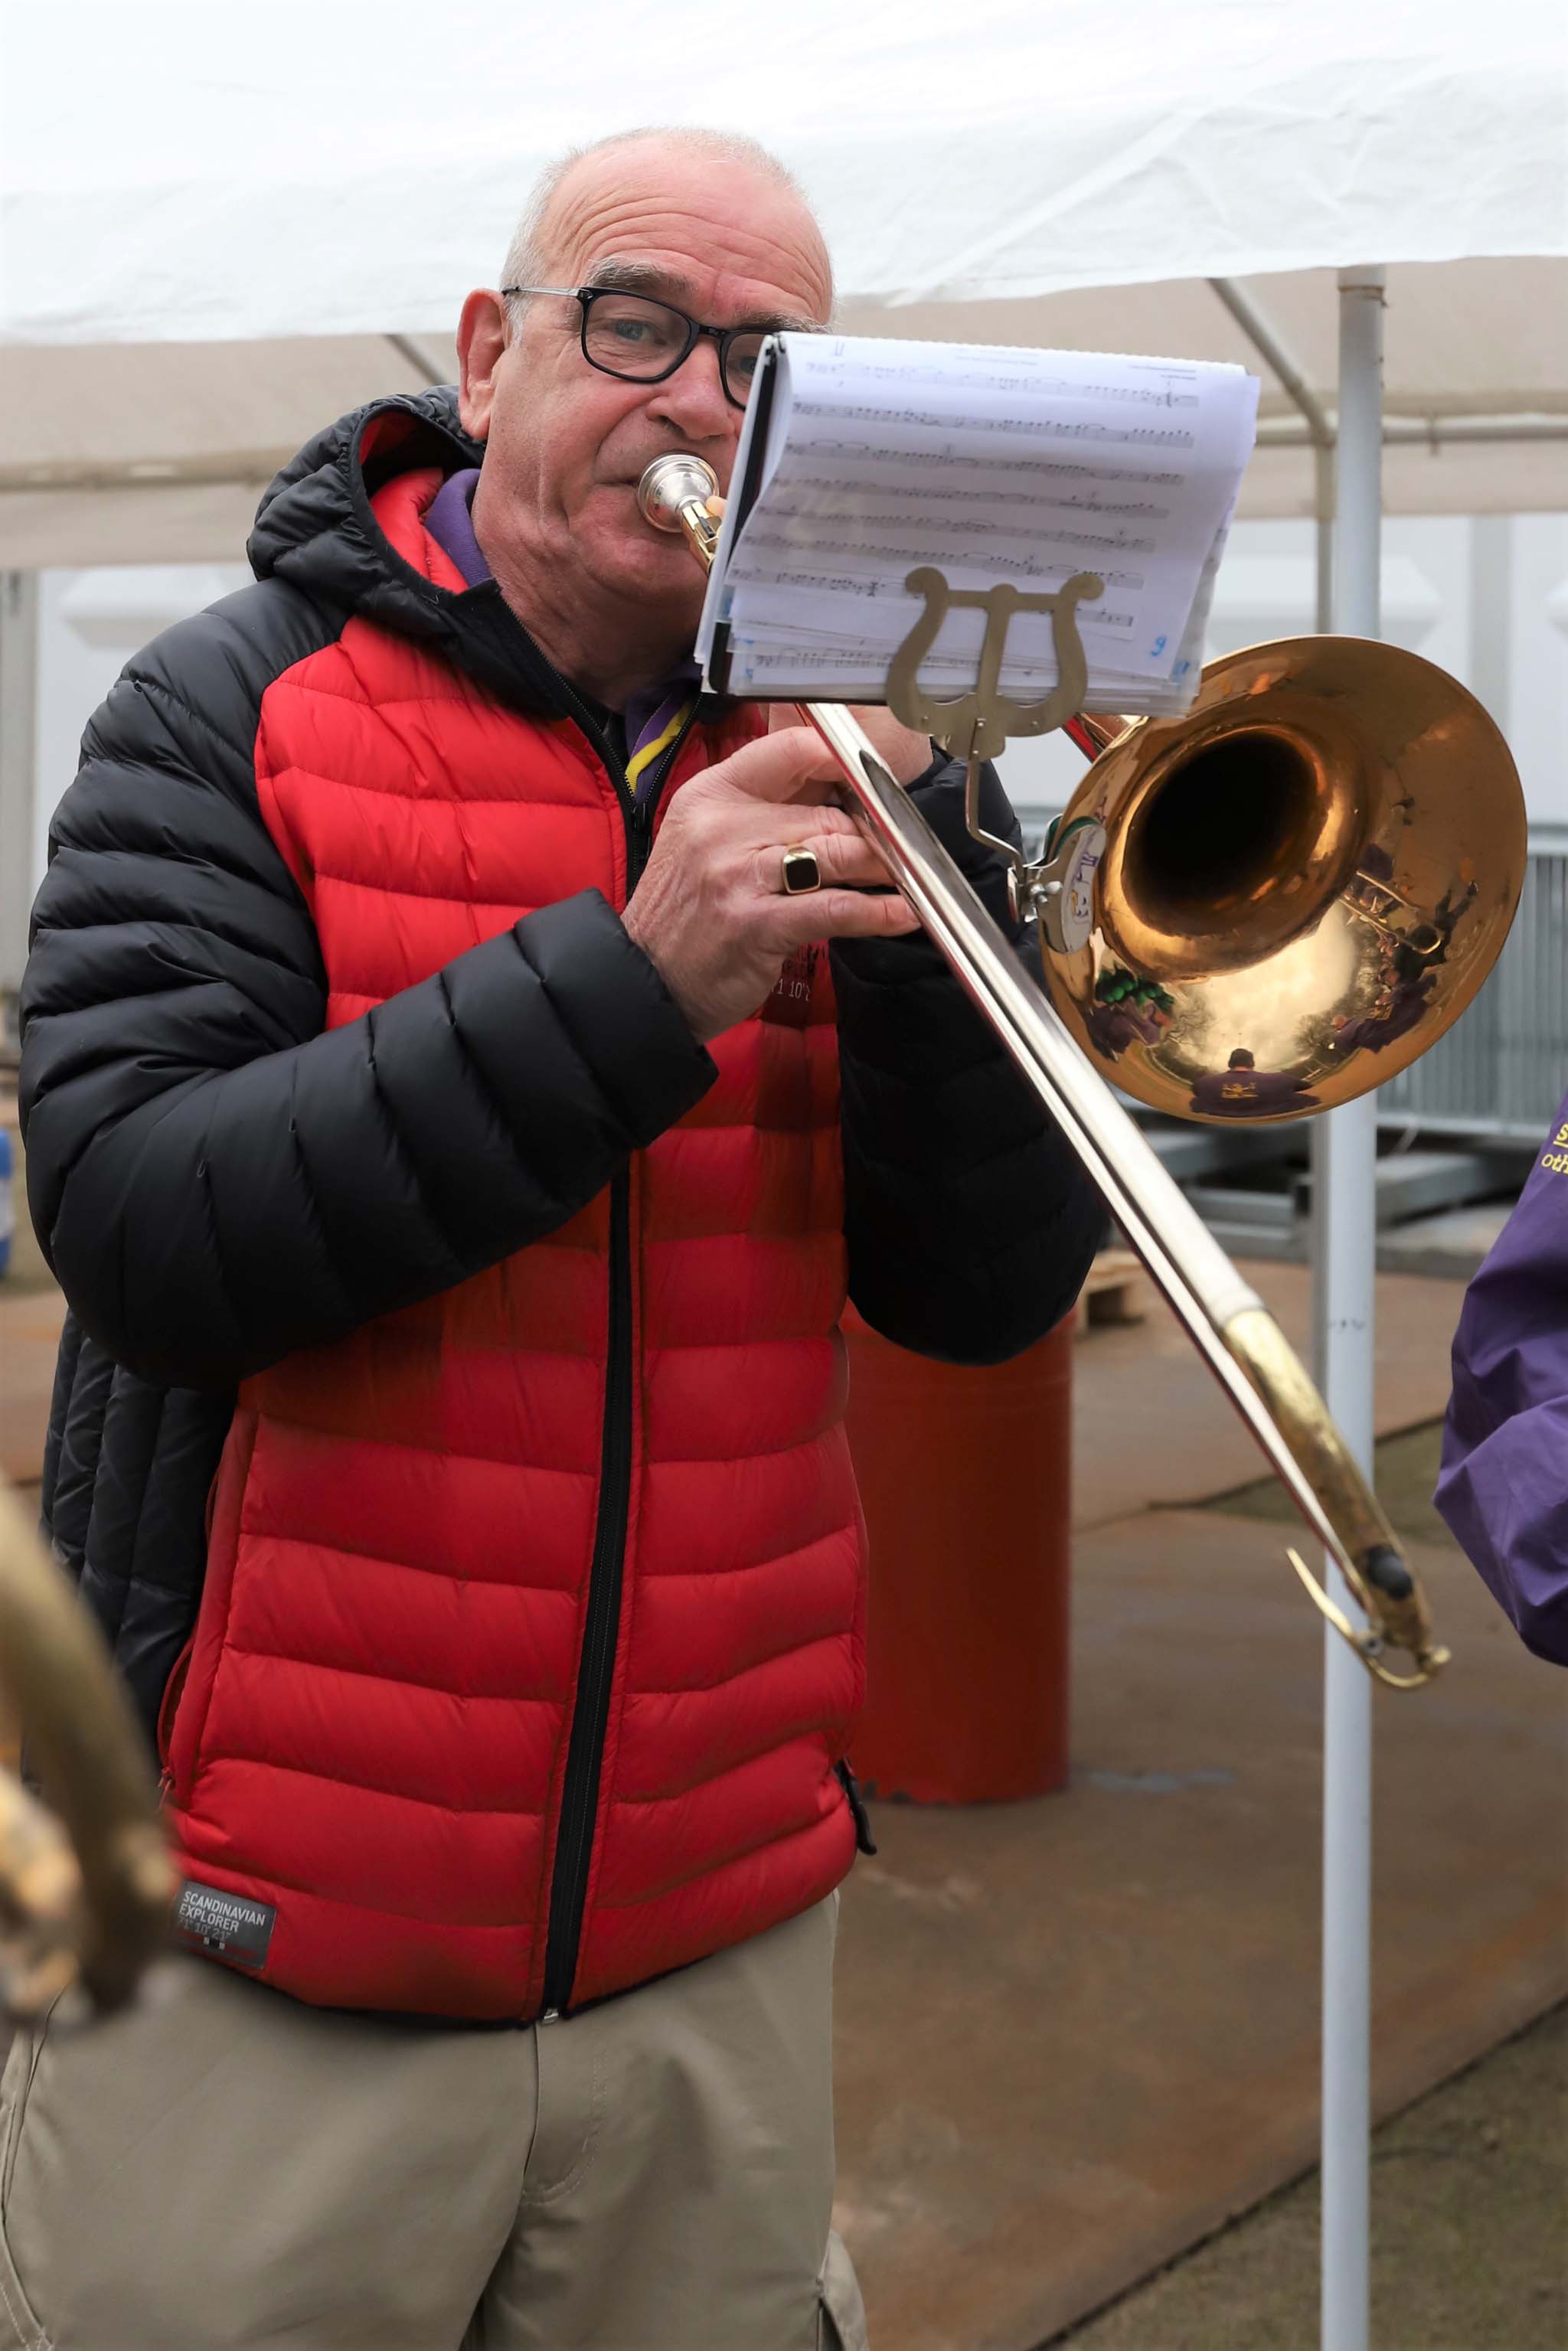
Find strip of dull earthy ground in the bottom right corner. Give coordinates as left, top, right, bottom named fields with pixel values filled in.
left=1054, top=2008, right=1568, bottom=2351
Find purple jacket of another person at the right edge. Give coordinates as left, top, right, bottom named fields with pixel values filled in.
left=1436, top=1100, right=1568, bottom=1664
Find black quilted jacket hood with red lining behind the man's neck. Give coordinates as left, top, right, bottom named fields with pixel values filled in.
left=244, top=384, right=485, bottom=637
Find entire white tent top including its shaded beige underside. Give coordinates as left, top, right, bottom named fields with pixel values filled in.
left=0, top=0, right=1568, bottom=567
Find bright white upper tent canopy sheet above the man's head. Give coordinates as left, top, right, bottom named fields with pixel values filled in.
left=0, top=0, right=1568, bottom=343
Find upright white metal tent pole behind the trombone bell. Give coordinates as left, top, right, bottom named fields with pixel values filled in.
left=1312, top=268, right=1385, bottom=2351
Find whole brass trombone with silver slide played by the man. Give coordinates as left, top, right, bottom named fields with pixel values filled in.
left=637, top=456, right=1526, bottom=1690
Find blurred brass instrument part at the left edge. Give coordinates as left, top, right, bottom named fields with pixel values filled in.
left=0, top=1481, right=174, bottom=2022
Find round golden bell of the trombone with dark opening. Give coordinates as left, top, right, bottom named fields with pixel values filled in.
left=1041, top=637, right=1526, bottom=1124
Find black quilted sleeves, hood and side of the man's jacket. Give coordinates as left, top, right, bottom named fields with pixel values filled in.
left=21, top=393, right=1102, bottom=1728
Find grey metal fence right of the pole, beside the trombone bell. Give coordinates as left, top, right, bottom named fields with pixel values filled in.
left=1018, top=808, right=1568, bottom=1143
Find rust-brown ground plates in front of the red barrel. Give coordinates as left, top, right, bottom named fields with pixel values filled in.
left=839, top=1485, right=1568, bottom=2351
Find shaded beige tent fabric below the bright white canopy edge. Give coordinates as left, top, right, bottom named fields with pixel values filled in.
left=0, top=258, right=1568, bottom=569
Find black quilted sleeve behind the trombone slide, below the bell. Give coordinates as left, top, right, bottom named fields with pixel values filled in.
left=832, top=762, right=1105, bottom=1363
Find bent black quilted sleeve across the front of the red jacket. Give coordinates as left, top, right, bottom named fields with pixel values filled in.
left=21, top=583, right=714, bottom=1387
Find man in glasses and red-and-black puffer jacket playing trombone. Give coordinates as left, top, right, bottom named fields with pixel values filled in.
left=0, top=134, right=1100, bottom=2351
